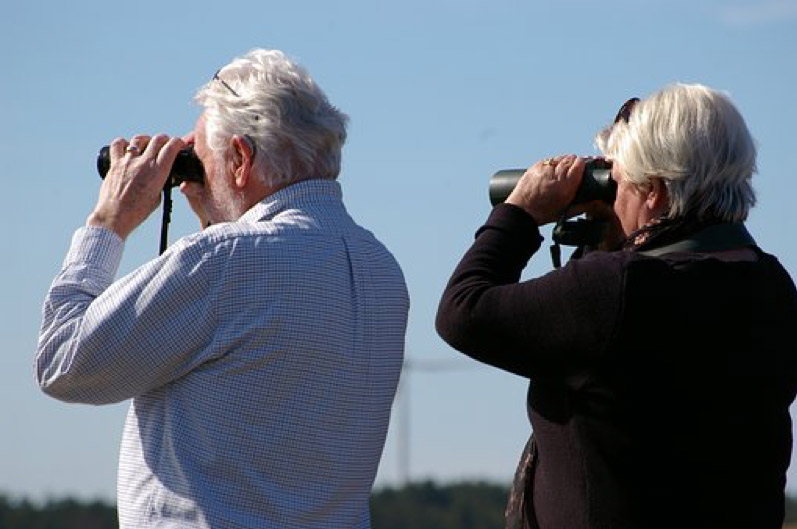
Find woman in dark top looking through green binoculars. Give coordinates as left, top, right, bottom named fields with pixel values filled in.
left=437, top=84, right=797, bottom=529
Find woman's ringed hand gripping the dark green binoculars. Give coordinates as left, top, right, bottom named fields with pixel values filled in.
left=506, top=154, right=586, bottom=226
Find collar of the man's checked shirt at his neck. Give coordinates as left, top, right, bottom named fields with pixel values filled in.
left=238, top=178, right=343, bottom=222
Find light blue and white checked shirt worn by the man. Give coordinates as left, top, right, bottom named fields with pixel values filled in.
left=35, top=180, right=409, bottom=529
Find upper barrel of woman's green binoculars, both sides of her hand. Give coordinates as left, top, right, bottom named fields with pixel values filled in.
left=490, top=158, right=617, bottom=206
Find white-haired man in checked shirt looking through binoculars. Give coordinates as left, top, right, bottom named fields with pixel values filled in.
left=35, top=50, right=409, bottom=529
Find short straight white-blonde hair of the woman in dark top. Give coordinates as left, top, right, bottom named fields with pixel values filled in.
left=595, top=83, right=756, bottom=222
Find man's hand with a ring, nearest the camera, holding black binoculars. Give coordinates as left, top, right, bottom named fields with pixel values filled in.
left=86, top=134, right=185, bottom=239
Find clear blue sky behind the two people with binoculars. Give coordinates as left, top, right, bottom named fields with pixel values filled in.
left=0, top=0, right=797, bottom=499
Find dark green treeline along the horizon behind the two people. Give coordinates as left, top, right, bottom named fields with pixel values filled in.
left=0, top=481, right=797, bottom=529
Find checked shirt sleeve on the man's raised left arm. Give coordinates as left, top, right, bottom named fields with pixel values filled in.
left=35, top=227, right=215, bottom=404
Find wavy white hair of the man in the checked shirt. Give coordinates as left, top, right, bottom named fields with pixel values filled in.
left=196, top=49, right=348, bottom=186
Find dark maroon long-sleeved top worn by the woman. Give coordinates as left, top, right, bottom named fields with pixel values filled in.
left=437, top=204, right=797, bottom=529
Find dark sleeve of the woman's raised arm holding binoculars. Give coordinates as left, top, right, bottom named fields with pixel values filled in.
left=436, top=204, right=623, bottom=378
